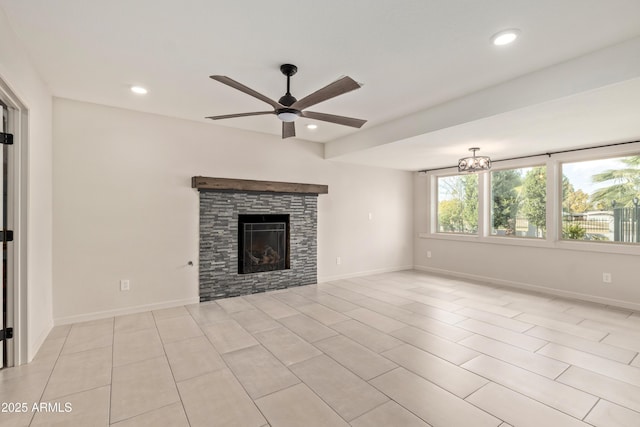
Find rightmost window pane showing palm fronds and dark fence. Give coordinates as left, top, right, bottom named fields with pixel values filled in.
left=562, top=156, right=640, bottom=243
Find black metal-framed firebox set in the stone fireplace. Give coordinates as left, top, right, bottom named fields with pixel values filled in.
left=238, top=215, right=290, bottom=274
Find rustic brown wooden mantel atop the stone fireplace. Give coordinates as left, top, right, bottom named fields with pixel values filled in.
left=191, top=176, right=329, bottom=194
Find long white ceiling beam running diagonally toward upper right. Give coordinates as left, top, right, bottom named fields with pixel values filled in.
left=324, top=37, right=640, bottom=159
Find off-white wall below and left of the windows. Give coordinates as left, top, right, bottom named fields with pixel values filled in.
left=414, top=174, right=640, bottom=310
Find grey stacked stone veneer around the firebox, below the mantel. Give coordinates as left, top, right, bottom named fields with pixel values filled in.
left=200, top=191, right=318, bottom=301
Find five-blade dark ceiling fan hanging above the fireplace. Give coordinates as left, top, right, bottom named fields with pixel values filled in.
left=207, top=64, right=367, bottom=139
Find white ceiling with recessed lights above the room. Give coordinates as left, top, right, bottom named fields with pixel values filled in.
left=0, top=0, right=640, bottom=170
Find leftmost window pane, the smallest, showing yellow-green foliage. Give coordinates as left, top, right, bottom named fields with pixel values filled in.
left=438, top=174, right=478, bottom=234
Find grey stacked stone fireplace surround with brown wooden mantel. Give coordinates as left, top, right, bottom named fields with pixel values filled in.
left=192, top=177, right=328, bottom=301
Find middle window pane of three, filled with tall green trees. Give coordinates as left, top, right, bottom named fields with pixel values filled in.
left=491, top=166, right=547, bottom=238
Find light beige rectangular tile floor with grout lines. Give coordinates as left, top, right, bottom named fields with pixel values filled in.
left=0, top=271, right=640, bottom=427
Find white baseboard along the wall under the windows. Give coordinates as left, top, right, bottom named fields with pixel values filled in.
left=413, top=265, right=640, bottom=311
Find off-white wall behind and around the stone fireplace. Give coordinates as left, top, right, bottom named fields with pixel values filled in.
left=53, top=99, right=413, bottom=323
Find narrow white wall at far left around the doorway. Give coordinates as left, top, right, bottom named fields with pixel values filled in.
left=0, top=9, right=52, bottom=360
